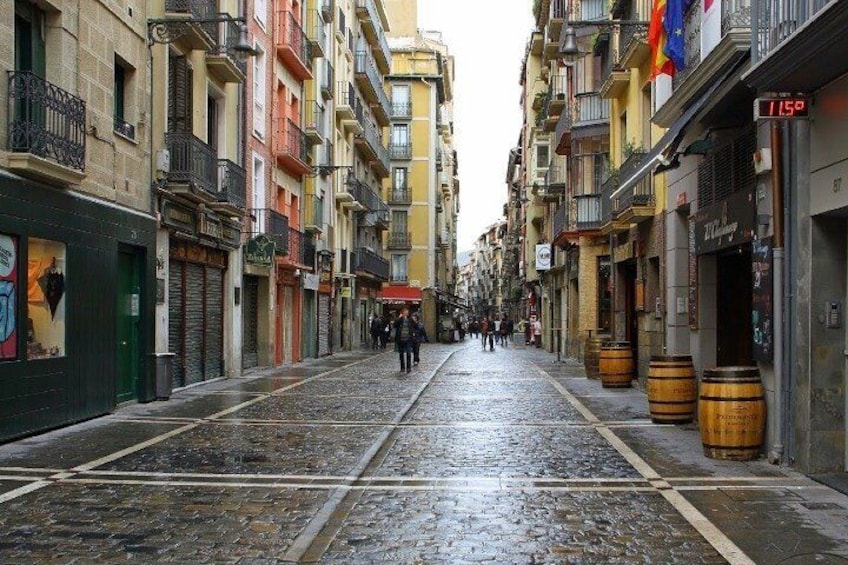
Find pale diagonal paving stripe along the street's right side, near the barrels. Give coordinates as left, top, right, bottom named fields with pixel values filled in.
left=537, top=365, right=755, bottom=565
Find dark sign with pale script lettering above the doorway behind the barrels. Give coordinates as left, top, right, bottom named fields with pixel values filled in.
left=695, top=190, right=756, bottom=255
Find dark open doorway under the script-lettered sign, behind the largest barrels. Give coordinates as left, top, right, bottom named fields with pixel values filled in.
left=716, top=245, right=754, bottom=366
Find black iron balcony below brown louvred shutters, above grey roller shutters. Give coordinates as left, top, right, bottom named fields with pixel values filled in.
left=165, top=132, right=218, bottom=203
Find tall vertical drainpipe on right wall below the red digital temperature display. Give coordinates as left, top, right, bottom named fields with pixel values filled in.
left=768, top=120, right=784, bottom=465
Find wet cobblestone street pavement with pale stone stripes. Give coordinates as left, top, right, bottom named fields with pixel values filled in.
left=0, top=342, right=848, bottom=565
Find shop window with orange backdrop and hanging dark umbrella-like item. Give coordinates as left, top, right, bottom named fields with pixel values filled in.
left=26, top=239, right=66, bottom=359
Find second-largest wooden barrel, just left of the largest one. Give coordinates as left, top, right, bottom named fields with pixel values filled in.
left=647, top=355, right=698, bottom=424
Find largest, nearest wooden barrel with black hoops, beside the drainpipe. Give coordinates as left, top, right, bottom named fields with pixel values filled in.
left=698, top=367, right=766, bottom=461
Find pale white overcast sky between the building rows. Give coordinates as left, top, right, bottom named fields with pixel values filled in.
left=418, top=0, right=533, bottom=251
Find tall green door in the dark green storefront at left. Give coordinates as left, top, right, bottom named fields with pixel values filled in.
left=115, top=250, right=142, bottom=402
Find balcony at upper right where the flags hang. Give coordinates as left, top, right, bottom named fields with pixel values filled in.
left=651, top=0, right=751, bottom=128
